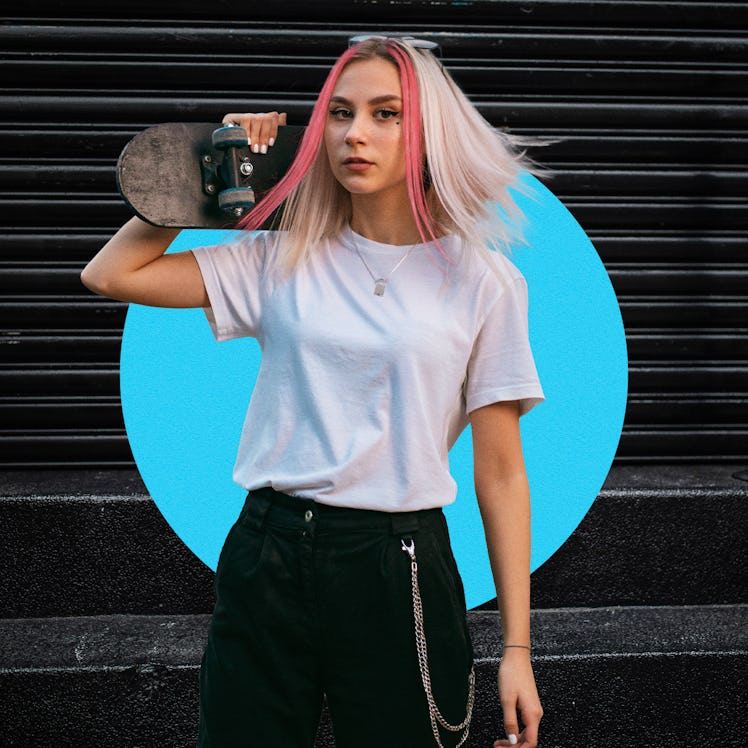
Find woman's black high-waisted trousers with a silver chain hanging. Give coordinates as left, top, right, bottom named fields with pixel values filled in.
left=198, top=488, right=473, bottom=748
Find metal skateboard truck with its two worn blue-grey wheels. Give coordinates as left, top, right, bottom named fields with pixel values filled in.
left=200, top=125, right=255, bottom=218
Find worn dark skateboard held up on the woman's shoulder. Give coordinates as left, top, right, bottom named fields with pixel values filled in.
left=117, top=122, right=304, bottom=228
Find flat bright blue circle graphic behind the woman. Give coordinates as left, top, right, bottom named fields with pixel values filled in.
left=120, top=176, right=628, bottom=607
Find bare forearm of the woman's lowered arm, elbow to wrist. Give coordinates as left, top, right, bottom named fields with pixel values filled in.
left=476, top=470, right=530, bottom=646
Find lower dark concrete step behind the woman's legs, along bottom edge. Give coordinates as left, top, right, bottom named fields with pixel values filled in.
left=0, top=605, right=748, bottom=748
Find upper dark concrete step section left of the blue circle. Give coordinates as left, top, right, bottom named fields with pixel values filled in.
left=0, top=470, right=215, bottom=618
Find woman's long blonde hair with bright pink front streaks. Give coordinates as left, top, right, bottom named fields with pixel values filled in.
left=240, top=38, right=532, bottom=271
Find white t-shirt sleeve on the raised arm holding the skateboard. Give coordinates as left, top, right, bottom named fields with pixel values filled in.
left=192, top=232, right=267, bottom=341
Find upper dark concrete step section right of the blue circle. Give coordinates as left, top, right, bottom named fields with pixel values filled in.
left=532, top=464, right=748, bottom=608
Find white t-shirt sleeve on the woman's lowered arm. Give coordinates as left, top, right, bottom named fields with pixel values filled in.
left=465, top=276, right=545, bottom=415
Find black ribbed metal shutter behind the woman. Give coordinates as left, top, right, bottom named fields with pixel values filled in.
left=0, top=0, right=748, bottom=467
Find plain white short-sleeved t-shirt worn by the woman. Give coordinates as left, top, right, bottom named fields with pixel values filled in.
left=193, top=229, right=543, bottom=511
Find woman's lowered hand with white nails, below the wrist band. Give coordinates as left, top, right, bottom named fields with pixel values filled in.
left=494, top=648, right=543, bottom=748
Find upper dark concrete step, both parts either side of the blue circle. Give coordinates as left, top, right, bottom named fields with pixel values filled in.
left=0, top=465, right=748, bottom=618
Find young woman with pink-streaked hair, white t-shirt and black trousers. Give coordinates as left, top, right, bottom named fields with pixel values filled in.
left=82, top=37, right=543, bottom=748
